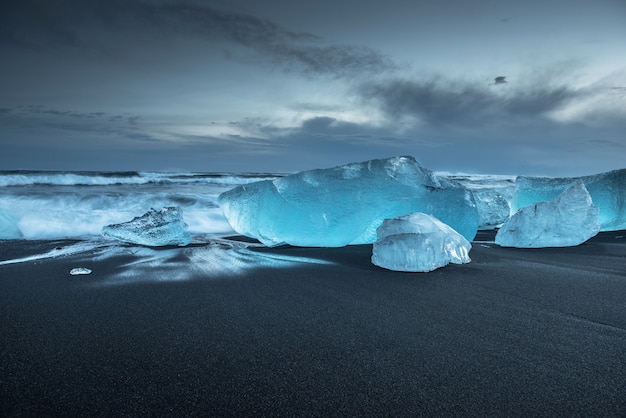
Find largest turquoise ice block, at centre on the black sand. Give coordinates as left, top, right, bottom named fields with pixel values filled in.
left=218, top=157, right=478, bottom=247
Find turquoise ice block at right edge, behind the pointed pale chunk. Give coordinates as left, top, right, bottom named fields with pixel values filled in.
left=511, top=168, right=626, bottom=231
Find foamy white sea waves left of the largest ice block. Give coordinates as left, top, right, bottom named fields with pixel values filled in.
left=0, top=171, right=279, bottom=239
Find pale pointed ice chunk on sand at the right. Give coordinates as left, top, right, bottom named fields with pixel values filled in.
left=496, top=180, right=600, bottom=248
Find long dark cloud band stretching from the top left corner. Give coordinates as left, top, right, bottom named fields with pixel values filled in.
left=0, top=0, right=395, bottom=76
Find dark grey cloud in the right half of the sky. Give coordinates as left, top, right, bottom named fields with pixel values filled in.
left=357, top=77, right=583, bottom=125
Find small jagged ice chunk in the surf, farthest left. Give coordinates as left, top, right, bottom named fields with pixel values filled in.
left=102, top=206, right=191, bottom=247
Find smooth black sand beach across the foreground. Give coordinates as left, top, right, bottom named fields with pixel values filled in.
left=0, top=231, right=626, bottom=417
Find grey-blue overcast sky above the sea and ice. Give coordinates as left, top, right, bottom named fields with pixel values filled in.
left=0, top=0, right=626, bottom=175
